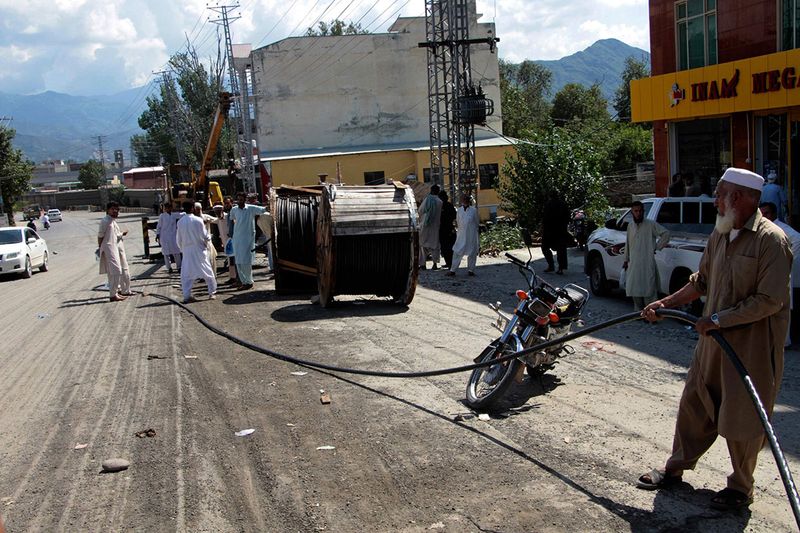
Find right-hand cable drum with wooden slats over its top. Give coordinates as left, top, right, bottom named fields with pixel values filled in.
left=317, top=182, right=419, bottom=307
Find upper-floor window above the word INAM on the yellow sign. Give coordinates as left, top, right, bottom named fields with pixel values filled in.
left=675, top=0, right=720, bottom=70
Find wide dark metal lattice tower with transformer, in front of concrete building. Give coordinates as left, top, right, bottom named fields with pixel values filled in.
left=420, top=0, right=499, bottom=203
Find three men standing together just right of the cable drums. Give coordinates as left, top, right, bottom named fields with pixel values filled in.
left=417, top=185, right=480, bottom=276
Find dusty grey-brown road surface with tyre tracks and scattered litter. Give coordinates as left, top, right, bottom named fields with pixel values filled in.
left=0, top=212, right=800, bottom=532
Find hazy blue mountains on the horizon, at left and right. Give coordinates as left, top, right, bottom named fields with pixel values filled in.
left=0, top=39, right=650, bottom=162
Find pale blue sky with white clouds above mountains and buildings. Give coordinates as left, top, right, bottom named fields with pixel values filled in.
left=0, top=0, right=649, bottom=95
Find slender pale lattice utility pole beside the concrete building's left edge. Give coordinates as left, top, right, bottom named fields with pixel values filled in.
left=208, top=2, right=256, bottom=193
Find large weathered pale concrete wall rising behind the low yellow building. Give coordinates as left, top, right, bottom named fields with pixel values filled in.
left=247, top=1, right=502, bottom=158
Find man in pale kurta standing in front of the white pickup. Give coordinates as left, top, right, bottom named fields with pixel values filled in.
left=622, top=202, right=669, bottom=311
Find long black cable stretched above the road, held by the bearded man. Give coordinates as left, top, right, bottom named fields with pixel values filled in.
left=150, top=293, right=800, bottom=529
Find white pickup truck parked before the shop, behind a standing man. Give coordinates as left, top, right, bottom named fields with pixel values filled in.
left=584, top=196, right=717, bottom=302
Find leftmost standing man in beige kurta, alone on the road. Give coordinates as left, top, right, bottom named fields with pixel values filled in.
left=97, top=202, right=131, bottom=302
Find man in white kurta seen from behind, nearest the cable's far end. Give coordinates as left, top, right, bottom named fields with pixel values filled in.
left=176, top=202, right=217, bottom=303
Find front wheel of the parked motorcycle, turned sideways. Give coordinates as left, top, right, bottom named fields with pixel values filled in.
left=467, top=339, right=522, bottom=409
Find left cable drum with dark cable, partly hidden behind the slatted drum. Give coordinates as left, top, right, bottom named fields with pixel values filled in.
left=270, top=186, right=322, bottom=293
